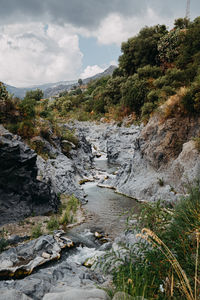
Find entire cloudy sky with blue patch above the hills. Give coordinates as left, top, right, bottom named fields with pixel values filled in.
left=0, top=0, right=200, bottom=87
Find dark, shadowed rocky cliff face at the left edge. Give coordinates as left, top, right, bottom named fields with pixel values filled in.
left=0, top=125, right=59, bottom=225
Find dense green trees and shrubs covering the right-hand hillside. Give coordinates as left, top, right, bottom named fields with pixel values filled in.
left=18, top=17, right=200, bottom=121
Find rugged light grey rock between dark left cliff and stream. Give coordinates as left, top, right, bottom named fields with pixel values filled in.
left=37, top=125, right=93, bottom=202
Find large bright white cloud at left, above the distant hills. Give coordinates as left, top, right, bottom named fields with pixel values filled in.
left=0, top=23, right=83, bottom=86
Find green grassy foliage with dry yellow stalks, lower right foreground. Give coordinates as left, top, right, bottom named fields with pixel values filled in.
left=101, top=181, right=200, bottom=300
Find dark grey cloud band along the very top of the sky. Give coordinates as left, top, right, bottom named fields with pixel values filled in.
left=0, top=0, right=200, bottom=29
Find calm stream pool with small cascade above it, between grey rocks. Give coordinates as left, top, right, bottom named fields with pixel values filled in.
left=72, top=155, right=139, bottom=239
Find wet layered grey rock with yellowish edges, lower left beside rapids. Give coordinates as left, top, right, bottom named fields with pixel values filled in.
left=0, top=232, right=73, bottom=278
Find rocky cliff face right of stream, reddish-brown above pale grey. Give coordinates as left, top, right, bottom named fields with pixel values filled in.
left=99, top=115, right=200, bottom=203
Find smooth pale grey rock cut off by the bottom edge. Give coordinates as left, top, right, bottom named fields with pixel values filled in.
left=43, top=287, right=110, bottom=300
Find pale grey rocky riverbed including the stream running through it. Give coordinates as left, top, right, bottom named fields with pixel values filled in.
left=0, top=119, right=200, bottom=300
